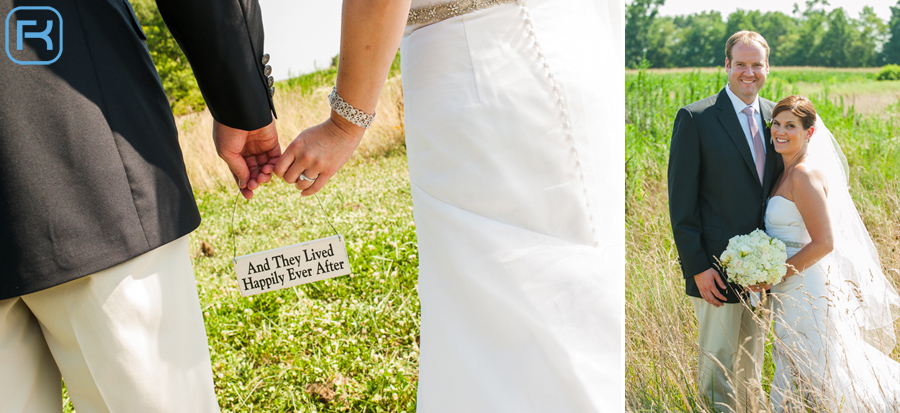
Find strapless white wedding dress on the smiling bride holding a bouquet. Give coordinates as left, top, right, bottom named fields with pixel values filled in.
left=765, top=196, right=900, bottom=412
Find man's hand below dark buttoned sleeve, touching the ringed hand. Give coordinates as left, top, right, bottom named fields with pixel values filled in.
left=213, top=120, right=281, bottom=199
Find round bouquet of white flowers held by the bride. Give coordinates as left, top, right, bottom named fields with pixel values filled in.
left=719, top=229, right=787, bottom=287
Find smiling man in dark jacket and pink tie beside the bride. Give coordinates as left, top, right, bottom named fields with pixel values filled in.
left=668, top=31, right=784, bottom=411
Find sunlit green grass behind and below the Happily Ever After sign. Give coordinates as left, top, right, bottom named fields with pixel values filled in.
left=191, top=153, right=419, bottom=412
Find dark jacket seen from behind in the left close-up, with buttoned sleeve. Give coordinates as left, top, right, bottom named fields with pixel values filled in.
left=0, top=0, right=272, bottom=299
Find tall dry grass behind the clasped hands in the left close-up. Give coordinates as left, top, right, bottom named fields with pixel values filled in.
left=176, top=76, right=405, bottom=190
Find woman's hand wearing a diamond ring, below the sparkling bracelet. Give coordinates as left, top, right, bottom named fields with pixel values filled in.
left=275, top=112, right=365, bottom=196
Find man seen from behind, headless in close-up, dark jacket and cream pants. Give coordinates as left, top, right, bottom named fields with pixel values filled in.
left=0, top=0, right=280, bottom=412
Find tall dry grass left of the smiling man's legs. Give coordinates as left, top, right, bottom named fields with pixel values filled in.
left=625, top=174, right=702, bottom=411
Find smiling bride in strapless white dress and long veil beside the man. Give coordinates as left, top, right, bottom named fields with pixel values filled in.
left=765, top=96, right=900, bottom=412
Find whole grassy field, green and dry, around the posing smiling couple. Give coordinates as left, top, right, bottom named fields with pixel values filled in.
left=625, top=68, right=900, bottom=412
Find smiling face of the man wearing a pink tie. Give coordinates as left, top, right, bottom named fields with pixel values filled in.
left=725, top=43, right=769, bottom=105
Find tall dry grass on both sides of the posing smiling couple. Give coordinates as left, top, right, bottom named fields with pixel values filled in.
left=625, top=175, right=900, bottom=412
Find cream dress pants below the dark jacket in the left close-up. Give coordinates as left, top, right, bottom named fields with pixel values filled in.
left=0, top=236, right=219, bottom=413
